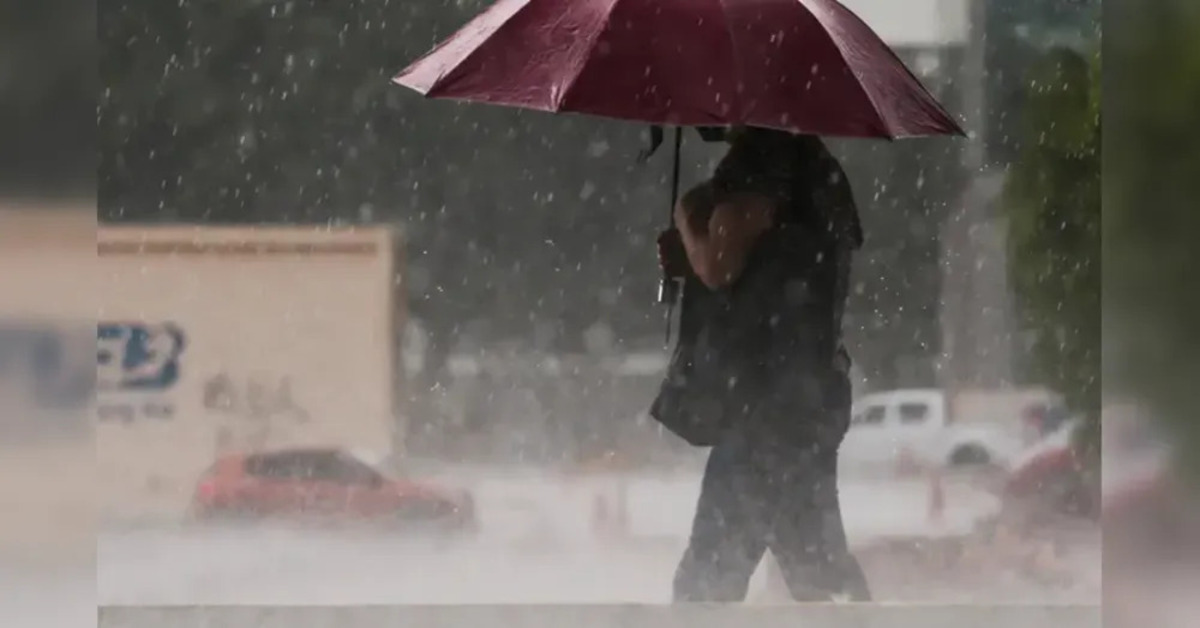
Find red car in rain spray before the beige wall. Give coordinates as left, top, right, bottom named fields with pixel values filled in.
left=192, top=449, right=476, bottom=531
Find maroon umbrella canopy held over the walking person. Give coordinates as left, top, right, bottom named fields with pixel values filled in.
left=395, top=0, right=962, bottom=138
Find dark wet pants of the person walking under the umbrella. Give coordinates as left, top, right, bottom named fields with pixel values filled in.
left=674, top=436, right=870, bottom=603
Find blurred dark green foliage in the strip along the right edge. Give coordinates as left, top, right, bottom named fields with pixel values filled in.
left=1104, top=0, right=1200, bottom=471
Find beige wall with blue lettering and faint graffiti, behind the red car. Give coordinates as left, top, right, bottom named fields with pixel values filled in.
left=96, top=227, right=398, bottom=518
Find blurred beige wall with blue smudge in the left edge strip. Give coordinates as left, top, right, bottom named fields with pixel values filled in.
left=0, top=206, right=98, bottom=568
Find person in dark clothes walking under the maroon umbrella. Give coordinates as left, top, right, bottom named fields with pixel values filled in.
left=650, top=127, right=870, bottom=602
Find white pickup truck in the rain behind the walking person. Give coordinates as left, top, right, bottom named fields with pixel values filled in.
left=840, top=389, right=1070, bottom=471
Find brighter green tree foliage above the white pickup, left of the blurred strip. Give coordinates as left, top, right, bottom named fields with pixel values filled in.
left=1006, top=48, right=1102, bottom=453
